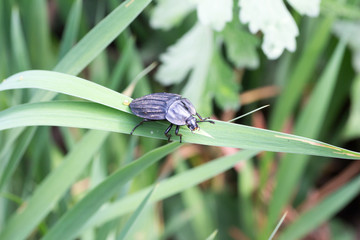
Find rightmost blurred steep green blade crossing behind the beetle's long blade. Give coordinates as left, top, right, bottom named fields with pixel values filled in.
left=268, top=41, right=346, bottom=231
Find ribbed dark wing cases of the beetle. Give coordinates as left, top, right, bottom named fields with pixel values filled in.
left=129, top=93, right=181, bottom=120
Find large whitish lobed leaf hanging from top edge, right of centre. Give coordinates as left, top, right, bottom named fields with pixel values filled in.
left=239, top=0, right=299, bottom=59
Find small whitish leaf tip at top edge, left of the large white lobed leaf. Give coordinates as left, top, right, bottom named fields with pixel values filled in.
left=197, top=0, right=233, bottom=32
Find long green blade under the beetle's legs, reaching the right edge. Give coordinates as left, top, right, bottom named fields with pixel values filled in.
left=0, top=101, right=360, bottom=159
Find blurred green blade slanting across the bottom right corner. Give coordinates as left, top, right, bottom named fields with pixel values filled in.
left=278, top=176, right=360, bottom=240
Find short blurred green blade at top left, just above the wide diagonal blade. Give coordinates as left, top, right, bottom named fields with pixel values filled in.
left=59, top=0, right=83, bottom=59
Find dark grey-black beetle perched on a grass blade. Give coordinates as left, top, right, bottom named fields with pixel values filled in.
left=129, top=93, right=215, bottom=142
